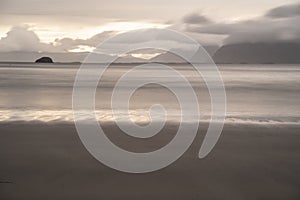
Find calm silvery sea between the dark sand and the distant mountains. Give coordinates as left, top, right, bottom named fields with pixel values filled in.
left=0, top=64, right=300, bottom=124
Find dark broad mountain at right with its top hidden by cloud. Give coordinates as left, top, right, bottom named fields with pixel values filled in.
left=213, top=43, right=300, bottom=64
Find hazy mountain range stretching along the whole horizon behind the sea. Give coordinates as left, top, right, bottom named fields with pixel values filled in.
left=0, top=43, right=300, bottom=64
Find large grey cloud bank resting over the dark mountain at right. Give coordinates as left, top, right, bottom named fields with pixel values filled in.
left=186, top=5, right=300, bottom=44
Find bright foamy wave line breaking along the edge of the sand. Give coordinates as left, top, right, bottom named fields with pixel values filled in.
left=0, top=109, right=300, bottom=125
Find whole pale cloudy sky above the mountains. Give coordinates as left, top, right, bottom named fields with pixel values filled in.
left=0, top=0, right=300, bottom=52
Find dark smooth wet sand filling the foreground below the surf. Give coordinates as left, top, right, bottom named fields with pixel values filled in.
left=0, top=123, right=300, bottom=200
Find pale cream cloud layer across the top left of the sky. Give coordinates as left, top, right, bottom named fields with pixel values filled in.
left=0, top=0, right=211, bottom=26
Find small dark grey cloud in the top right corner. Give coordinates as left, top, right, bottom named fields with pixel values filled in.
left=266, top=4, right=300, bottom=18
